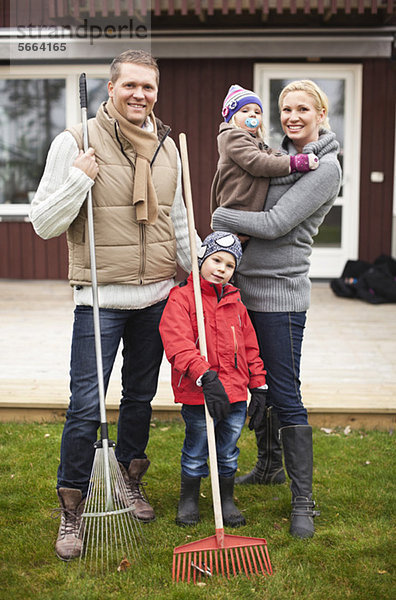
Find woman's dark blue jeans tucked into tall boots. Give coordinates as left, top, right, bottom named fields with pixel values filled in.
left=249, top=311, right=308, bottom=427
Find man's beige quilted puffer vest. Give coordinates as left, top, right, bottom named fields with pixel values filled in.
left=67, top=105, right=177, bottom=285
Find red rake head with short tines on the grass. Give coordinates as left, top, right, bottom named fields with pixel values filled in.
left=172, top=534, right=272, bottom=583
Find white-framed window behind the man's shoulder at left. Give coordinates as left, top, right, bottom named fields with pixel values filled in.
left=0, top=65, right=109, bottom=220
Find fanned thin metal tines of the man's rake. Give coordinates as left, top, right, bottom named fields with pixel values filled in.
left=80, top=448, right=144, bottom=572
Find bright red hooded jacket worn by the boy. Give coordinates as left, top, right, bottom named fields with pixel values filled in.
left=160, top=274, right=266, bottom=404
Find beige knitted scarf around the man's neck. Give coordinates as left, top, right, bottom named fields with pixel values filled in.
left=106, top=98, right=158, bottom=225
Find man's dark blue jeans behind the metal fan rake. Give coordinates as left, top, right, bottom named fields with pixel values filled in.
left=58, top=300, right=166, bottom=496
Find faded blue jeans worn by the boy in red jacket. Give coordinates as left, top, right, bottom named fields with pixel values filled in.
left=181, top=402, right=246, bottom=477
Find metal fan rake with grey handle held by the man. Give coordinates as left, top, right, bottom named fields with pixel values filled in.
left=75, top=73, right=144, bottom=572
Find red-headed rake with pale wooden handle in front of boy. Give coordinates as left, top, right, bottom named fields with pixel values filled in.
left=176, top=133, right=272, bottom=583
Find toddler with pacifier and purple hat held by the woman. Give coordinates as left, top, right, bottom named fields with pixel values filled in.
left=211, top=85, right=319, bottom=212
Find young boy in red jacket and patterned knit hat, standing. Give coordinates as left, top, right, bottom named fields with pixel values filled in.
left=160, top=231, right=267, bottom=527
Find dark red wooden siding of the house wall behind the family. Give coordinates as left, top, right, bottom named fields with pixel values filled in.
left=0, top=59, right=395, bottom=279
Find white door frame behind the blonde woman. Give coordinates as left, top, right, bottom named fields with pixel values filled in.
left=254, top=63, right=362, bottom=278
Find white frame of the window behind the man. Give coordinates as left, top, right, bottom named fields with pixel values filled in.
left=0, top=63, right=109, bottom=221
